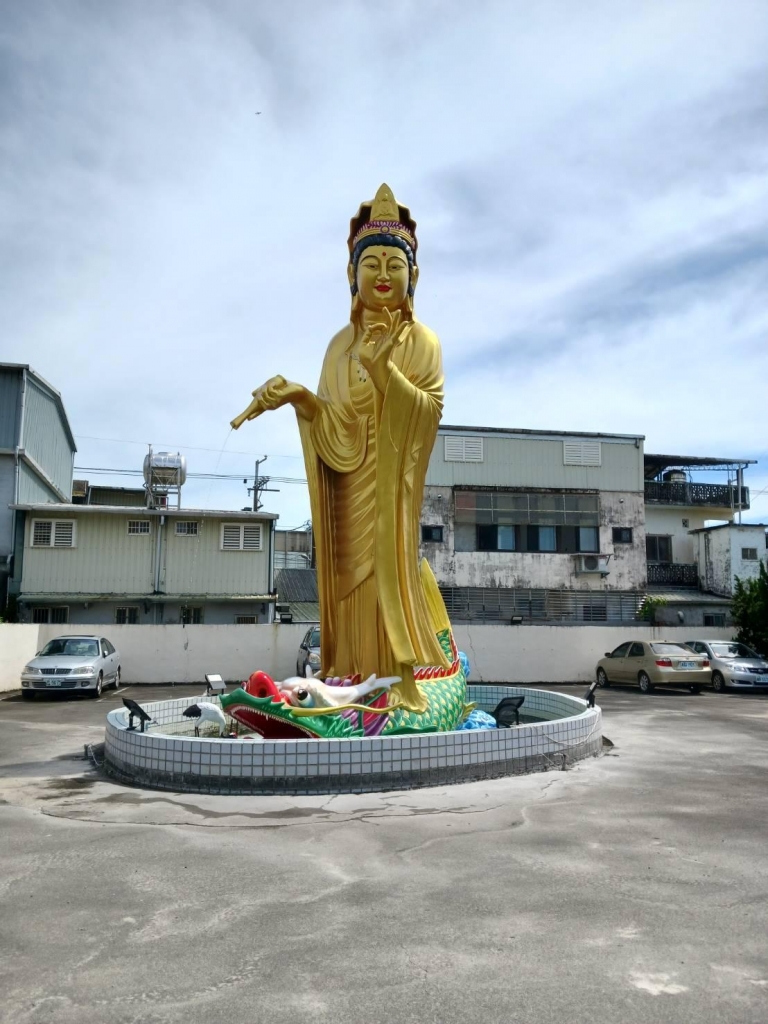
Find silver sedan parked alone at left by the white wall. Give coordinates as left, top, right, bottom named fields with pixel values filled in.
left=22, top=636, right=121, bottom=700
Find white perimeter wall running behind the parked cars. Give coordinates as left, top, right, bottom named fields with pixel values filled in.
left=0, top=625, right=733, bottom=690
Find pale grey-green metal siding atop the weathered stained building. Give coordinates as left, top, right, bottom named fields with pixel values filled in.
left=426, top=434, right=643, bottom=492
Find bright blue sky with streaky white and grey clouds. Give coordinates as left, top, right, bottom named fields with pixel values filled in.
left=0, top=0, right=768, bottom=527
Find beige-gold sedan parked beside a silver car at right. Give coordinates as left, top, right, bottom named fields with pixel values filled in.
left=597, top=640, right=712, bottom=693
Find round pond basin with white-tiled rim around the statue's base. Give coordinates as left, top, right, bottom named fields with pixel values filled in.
left=104, top=684, right=602, bottom=795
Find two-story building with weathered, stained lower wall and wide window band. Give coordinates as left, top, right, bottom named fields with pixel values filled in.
left=421, top=425, right=646, bottom=623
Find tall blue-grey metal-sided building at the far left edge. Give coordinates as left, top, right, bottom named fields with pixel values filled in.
left=0, top=362, right=77, bottom=613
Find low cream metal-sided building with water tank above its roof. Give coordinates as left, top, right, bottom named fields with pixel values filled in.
left=9, top=503, right=278, bottom=625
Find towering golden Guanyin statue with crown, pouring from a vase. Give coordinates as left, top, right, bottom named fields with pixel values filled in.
left=232, top=184, right=450, bottom=712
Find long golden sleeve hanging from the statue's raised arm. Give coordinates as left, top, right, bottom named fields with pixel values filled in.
left=375, top=324, right=449, bottom=667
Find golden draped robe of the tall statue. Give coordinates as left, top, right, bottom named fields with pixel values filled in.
left=298, top=322, right=447, bottom=711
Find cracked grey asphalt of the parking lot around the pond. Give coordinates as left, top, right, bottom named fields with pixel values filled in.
left=0, top=684, right=768, bottom=1024
